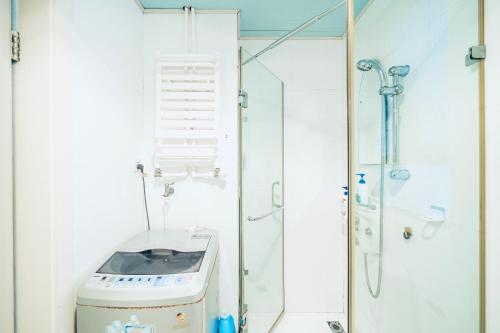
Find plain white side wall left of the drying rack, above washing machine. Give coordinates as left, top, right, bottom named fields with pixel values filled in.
left=71, top=0, right=145, bottom=286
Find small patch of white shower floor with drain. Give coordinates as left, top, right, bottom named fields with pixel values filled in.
left=273, top=313, right=346, bottom=333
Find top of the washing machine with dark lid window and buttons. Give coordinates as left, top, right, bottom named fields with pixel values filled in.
left=77, top=229, right=218, bottom=307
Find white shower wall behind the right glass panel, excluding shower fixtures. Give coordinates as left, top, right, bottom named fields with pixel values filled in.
left=355, top=0, right=480, bottom=333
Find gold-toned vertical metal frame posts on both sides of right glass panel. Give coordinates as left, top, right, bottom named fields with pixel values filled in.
left=346, top=0, right=486, bottom=333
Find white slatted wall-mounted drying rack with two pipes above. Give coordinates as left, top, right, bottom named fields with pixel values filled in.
left=154, top=7, right=224, bottom=182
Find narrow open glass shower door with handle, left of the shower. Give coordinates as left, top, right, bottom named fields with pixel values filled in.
left=241, top=50, right=284, bottom=333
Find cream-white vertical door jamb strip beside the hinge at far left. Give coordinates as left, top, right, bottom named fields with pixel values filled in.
left=14, top=0, right=59, bottom=333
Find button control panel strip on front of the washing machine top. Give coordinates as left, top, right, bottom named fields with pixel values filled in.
left=86, top=273, right=196, bottom=289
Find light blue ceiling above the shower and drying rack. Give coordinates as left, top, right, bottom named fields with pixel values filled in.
left=140, top=0, right=369, bottom=37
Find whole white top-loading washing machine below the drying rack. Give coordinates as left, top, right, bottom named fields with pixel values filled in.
left=76, top=229, right=219, bottom=333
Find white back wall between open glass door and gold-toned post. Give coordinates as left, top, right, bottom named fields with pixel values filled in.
left=240, top=40, right=347, bottom=313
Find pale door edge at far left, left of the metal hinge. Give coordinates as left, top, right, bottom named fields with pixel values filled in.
left=0, top=0, right=14, bottom=333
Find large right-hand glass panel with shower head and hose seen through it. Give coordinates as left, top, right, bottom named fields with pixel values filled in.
left=353, top=0, right=480, bottom=333
